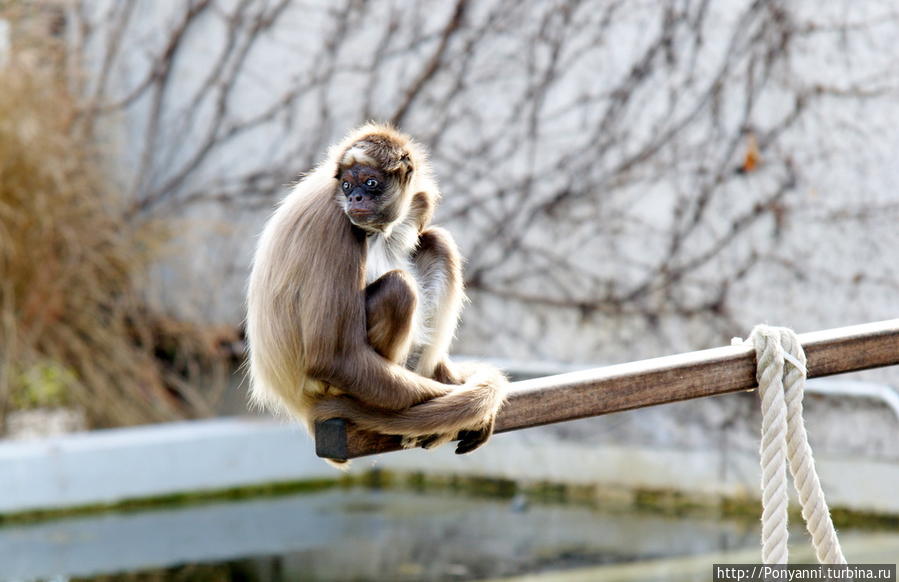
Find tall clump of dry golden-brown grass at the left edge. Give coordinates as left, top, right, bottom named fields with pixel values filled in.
left=0, top=53, right=227, bottom=432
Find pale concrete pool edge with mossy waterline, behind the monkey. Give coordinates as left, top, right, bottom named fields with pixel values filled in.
left=0, top=418, right=899, bottom=525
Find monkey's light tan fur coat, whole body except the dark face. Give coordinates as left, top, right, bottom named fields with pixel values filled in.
left=247, top=124, right=507, bottom=466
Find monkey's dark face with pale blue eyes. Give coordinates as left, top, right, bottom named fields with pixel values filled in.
left=337, top=164, right=398, bottom=231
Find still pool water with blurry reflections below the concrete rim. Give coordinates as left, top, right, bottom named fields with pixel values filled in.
left=0, top=488, right=899, bottom=582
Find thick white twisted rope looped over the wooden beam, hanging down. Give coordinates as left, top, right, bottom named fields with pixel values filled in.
left=731, top=325, right=846, bottom=564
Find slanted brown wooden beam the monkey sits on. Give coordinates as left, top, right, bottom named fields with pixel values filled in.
left=315, top=319, right=899, bottom=459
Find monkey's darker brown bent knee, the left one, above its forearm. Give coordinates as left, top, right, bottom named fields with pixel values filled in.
left=365, top=270, right=418, bottom=365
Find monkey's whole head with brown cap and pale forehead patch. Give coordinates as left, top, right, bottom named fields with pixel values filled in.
left=335, top=128, right=415, bottom=232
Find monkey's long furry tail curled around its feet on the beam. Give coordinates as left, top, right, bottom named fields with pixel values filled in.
left=315, top=366, right=508, bottom=437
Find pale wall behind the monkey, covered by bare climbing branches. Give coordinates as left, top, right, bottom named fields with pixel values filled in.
left=72, top=1, right=899, bottom=378
